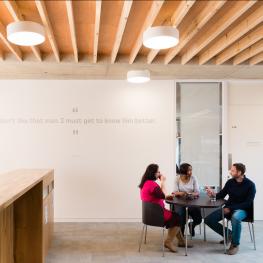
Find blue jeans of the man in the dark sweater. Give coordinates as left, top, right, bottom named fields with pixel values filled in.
left=205, top=208, right=247, bottom=246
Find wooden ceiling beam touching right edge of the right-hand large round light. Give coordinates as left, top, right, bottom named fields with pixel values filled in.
left=164, top=0, right=226, bottom=65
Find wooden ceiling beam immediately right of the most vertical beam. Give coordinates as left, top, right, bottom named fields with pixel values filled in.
left=111, top=0, right=132, bottom=63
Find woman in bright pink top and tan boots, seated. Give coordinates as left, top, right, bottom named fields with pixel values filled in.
left=139, top=164, right=188, bottom=252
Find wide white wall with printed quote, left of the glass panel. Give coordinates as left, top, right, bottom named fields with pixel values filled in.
left=0, top=80, right=175, bottom=221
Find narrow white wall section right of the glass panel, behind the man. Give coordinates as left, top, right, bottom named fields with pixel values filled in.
left=228, top=81, right=263, bottom=220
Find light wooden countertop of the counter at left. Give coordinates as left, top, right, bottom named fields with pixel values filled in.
left=0, top=169, right=54, bottom=210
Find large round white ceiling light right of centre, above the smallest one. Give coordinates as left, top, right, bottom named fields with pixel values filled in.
left=143, top=26, right=179, bottom=49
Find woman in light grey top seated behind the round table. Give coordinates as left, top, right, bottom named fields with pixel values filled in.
left=173, top=163, right=202, bottom=236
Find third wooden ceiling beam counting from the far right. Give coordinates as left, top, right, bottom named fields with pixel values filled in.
left=216, top=25, right=263, bottom=65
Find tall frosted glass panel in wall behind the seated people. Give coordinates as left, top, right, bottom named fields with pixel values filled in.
left=176, top=82, right=222, bottom=186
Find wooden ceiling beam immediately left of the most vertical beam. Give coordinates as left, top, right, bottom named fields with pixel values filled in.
left=65, top=0, right=79, bottom=62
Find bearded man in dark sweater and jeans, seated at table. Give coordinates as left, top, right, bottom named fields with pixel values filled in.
left=205, top=163, right=256, bottom=255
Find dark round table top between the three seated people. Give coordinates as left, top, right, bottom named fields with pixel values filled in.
left=165, top=196, right=225, bottom=208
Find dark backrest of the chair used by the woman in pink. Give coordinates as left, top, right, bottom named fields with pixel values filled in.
left=142, top=201, right=164, bottom=227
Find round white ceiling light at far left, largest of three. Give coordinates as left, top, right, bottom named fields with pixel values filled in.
left=6, top=21, right=45, bottom=46
